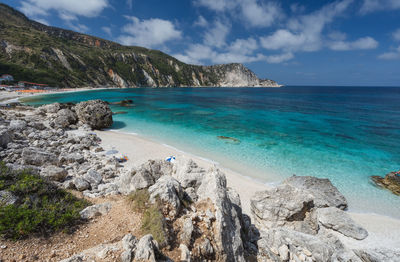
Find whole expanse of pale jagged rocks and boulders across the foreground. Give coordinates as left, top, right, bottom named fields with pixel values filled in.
left=0, top=100, right=400, bottom=262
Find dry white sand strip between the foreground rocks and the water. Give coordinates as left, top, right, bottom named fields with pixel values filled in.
left=96, top=131, right=400, bottom=249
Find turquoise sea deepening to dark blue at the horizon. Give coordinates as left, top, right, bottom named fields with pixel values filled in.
left=25, top=87, right=400, bottom=218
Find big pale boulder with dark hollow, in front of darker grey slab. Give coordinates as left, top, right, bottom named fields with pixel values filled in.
left=251, top=184, right=318, bottom=234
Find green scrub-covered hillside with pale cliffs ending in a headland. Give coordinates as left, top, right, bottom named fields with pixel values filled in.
left=0, top=4, right=278, bottom=87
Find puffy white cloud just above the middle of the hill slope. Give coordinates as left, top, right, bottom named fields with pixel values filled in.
left=118, top=16, right=182, bottom=47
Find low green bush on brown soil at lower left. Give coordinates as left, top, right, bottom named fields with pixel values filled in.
left=0, top=163, right=89, bottom=239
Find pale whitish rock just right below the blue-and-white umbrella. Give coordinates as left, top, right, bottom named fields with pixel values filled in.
left=173, top=159, right=206, bottom=189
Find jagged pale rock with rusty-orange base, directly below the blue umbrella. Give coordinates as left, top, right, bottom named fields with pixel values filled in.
left=148, top=175, right=183, bottom=217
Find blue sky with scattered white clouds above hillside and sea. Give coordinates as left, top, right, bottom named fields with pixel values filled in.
left=0, top=0, right=400, bottom=86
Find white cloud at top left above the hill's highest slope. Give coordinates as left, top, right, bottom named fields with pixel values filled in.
left=20, top=0, right=109, bottom=17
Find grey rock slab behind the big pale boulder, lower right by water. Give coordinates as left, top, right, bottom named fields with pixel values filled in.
left=283, top=176, right=348, bottom=209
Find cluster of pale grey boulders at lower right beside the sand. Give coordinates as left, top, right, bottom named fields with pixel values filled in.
left=251, top=176, right=374, bottom=261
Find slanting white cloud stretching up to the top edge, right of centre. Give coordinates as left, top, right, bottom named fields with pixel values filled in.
left=260, top=0, right=353, bottom=53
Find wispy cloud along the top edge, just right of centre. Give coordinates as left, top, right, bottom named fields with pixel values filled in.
left=194, top=0, right=284, bottom=27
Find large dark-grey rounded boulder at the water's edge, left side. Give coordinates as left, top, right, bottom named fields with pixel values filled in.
left=75, top=100, right=113, bottom=129
